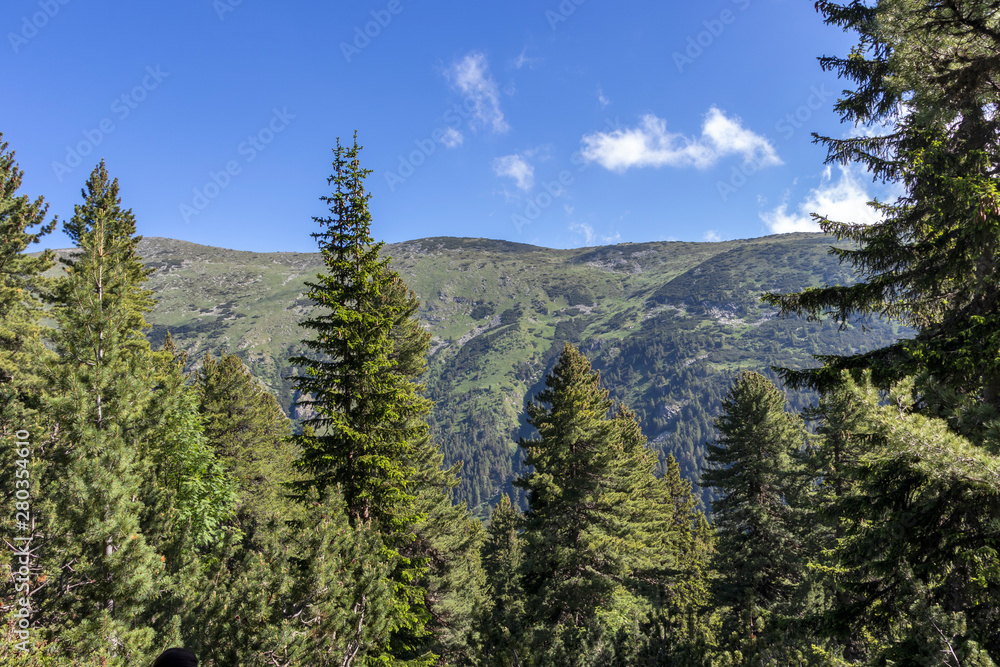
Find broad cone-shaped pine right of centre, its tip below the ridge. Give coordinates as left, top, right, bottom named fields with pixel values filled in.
left=515, top=344, right=672, bottom=664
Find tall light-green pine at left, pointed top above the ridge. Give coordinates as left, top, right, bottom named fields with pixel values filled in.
left=37, top=162, right=164, bottom=661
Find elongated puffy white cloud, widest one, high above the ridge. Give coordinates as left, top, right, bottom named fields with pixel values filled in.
left=582, top=107, right=782, bottom=171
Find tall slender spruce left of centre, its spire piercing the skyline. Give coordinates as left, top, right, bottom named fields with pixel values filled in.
left=291, top=136, right=435, bottom=664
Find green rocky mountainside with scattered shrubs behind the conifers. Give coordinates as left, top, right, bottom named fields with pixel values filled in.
left=48, top=234, right=901, bottom=511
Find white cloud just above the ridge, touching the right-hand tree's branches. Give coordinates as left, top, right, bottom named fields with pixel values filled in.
left=760, top=167, right=880, bottom=234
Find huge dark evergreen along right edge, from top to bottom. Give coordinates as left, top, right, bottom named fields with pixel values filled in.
left=765, top=0, right=1000, bottom=664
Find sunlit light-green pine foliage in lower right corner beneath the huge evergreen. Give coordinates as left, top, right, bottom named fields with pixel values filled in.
left=812, top=379, right=1000, bottom=664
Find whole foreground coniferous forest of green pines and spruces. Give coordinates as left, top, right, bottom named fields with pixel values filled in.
left=0, top=0, right=1000, bottom=667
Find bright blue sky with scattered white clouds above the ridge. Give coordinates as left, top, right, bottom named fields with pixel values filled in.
left=0, top=0, right=887, bottom=252
